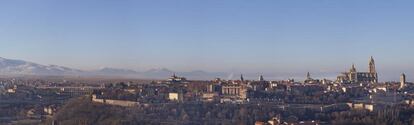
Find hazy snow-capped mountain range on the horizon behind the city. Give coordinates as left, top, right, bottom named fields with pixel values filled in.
left=0, top=57, right=227, bottom=79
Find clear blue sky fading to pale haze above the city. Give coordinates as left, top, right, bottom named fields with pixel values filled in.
left=0, top=0, right=414, bottom=80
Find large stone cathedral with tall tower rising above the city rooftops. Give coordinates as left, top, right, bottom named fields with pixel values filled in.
left=337, top=56, right=378, bottom=83
